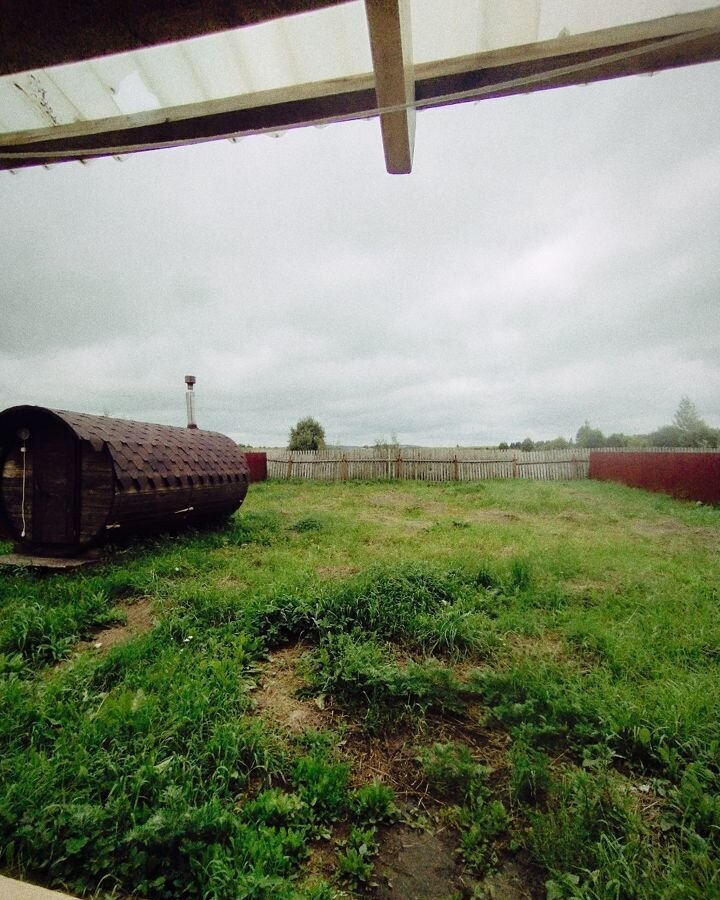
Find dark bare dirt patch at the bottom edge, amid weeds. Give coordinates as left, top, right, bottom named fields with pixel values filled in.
left=371, top=827, right=465, bottom=900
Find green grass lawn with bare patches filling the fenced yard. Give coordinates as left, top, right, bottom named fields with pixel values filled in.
left=0, top=481, right=720, bottom=900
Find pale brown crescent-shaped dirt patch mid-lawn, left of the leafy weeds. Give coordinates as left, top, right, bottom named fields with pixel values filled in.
left=255, top=644, right=333, bottom=732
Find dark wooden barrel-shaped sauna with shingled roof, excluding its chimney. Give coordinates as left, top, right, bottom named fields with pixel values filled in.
left=0, top=406, right=249, bottom=556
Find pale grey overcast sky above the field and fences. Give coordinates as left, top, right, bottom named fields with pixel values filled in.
left=0, top=63, right=720, bottom=446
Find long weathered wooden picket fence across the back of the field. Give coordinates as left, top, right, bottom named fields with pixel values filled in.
left=258, top=447, right=590, bottom=481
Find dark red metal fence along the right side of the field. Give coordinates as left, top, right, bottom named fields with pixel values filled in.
left=590, top=450, right=720, bottom=504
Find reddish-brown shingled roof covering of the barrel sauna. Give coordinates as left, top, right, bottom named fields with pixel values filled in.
left=54, top=410, right=248, bottom=490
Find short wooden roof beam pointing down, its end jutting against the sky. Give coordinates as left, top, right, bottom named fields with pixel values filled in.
left=365, top=0, right=415, bottom=175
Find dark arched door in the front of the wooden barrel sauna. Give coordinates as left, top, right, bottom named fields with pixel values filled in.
left=28, top=422, right=79, bottom=546
